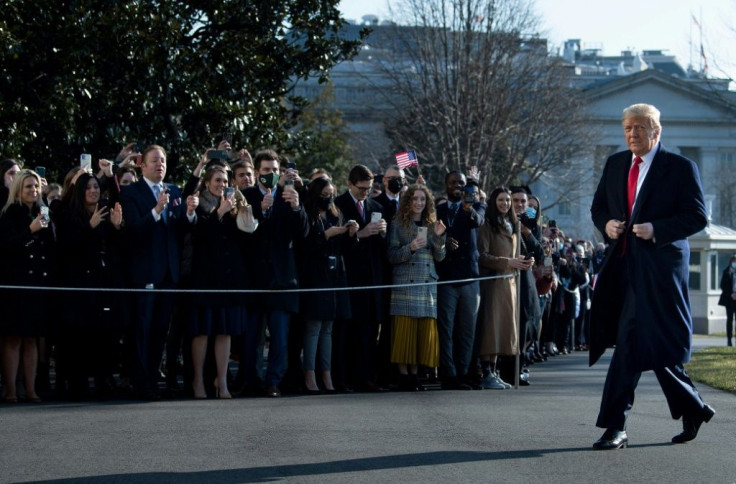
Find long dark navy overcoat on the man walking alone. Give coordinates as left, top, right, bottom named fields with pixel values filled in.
left=589, top=145, right=707, bottom=371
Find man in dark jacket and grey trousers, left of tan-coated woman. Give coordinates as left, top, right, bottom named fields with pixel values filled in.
left=436, top=171, right=486, bottom=390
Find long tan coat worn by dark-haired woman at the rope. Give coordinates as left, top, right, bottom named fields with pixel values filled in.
left=478, top=221, right=519, bottom=356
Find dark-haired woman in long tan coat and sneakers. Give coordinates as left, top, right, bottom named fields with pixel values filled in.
left=478, top=187, right=533, bottom=390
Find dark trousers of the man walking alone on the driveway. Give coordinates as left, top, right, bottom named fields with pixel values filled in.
left=596, top=289, right=704, bottom=430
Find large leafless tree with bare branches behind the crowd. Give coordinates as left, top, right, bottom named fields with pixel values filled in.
left=384, top=0, right=592, bottom=194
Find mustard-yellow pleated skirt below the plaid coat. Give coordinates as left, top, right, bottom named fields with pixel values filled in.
left=391, top=316, right=440, bottom=368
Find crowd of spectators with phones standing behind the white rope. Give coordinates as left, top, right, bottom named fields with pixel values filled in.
left=0, top=141, right=605, bottom=403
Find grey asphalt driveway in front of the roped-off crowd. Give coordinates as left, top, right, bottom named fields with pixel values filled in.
left=0, top=337, right=736, bottom=484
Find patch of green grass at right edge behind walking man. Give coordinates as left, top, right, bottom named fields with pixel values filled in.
left=685, top=346, right=736, bottom=393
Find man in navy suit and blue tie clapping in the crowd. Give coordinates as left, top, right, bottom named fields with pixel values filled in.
left=120, top=145, right=199, bottom=399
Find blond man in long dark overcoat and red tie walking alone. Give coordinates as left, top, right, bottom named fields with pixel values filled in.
left=590, top=104, right=715, bottom=450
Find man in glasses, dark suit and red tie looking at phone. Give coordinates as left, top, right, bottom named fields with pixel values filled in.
left=333, top=165, right=390, bottom=391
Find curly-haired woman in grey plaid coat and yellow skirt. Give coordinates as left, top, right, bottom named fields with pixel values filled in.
left=388, top=185, right=445, bottom=390
